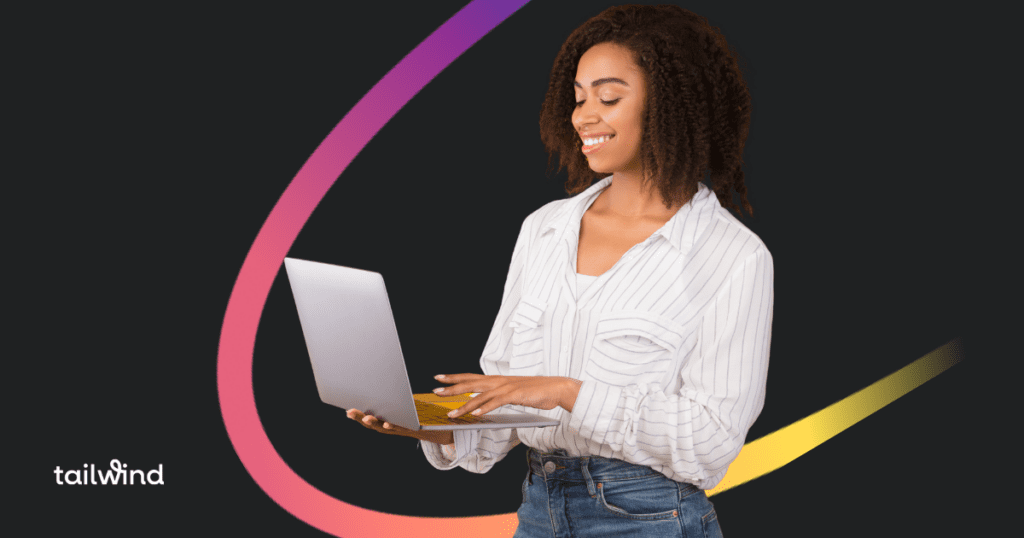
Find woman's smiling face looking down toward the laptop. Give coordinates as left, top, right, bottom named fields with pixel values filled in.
left=572, top=43, right=646, bottom=173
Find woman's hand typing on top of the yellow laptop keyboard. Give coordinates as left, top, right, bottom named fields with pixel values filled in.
left=434, top=374, right=580, bottom=418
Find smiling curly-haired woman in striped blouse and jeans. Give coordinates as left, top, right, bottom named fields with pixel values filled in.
left=348, top=6, right=773, bottom=537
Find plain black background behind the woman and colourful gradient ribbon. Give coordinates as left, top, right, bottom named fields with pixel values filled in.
left=18, top=0, right=1009, bottom=536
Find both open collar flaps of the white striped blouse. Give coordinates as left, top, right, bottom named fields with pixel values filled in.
left=541, top=175, right=722, bottom=253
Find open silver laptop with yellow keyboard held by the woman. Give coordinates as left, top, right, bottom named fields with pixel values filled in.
left=285, top=258, right=558, bottom=429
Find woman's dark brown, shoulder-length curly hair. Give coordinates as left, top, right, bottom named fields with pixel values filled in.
left=541, top=5, right=754, bottom=215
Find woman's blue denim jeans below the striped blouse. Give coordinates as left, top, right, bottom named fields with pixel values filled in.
left=513, top=449, right=722, bottom=538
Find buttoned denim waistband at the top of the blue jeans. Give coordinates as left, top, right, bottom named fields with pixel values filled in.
left=526, top=448, right=697, bottom=490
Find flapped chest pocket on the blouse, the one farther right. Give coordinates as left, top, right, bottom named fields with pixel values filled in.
left=584, top=311, right=684, bottom=386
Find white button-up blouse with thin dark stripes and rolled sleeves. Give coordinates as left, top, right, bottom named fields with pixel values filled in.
left=423, top=177, right=773, bottom=489
